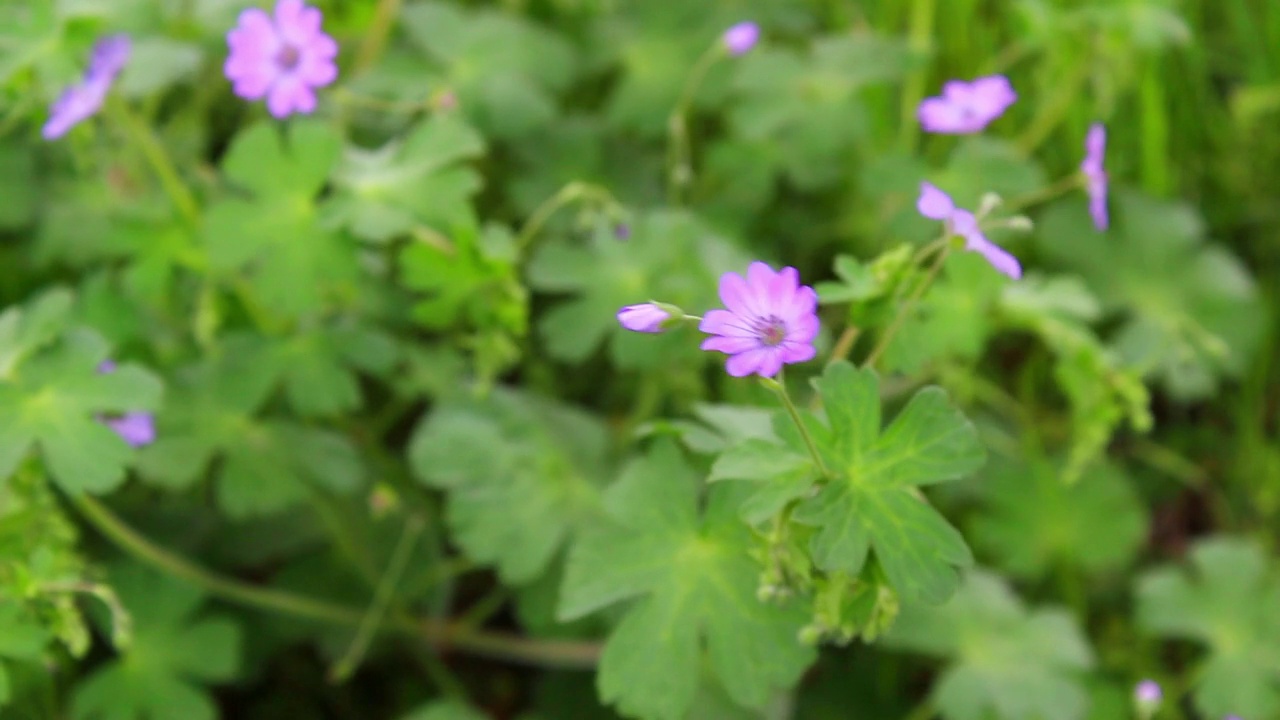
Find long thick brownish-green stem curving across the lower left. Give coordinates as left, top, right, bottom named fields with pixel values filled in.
left=70, top=495, right=600, bottom=667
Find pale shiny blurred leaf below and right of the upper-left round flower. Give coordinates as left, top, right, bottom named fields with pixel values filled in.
left=323, top=114, right=485, bottom=242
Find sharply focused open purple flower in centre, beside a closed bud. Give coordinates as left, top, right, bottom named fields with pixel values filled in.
left=698, top=261, right=818, bottom=378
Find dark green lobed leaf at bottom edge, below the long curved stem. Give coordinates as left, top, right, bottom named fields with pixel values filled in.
left=72, top=565, right=241, bottom=720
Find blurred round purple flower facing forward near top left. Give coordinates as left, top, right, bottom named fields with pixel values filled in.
left=223, top=0, right=338, bottom=118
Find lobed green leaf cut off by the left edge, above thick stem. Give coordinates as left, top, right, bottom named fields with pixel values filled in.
left=0, top=291, right=161, bottom=495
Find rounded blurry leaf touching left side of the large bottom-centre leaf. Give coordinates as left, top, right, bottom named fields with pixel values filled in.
left=410, top=389, right=607, bottom=584
